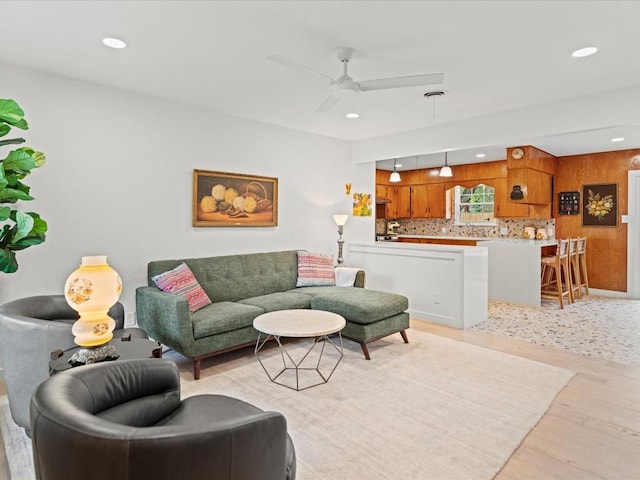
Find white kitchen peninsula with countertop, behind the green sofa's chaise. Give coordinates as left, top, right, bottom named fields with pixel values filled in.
left=356, top=235, right=557, bottom=328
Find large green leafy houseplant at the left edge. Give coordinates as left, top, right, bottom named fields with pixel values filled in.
left=0, top=99, right=47, bottom=273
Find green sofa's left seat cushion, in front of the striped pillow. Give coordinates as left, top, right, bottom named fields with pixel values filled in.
left=191, top=302, right=265, bottom=340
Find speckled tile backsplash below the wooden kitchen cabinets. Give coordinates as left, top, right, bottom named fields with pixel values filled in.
left=376, top=218, right=555, bottom=238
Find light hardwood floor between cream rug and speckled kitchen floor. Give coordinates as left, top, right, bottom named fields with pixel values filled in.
left=409, top=320, right=640, bottom=480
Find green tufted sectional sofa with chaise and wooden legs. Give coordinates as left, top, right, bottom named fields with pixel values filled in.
left=136, top=250, right=409, bottom=379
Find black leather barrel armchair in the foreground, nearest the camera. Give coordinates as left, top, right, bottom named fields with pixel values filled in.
left=31, top=359, right=296, bottom=480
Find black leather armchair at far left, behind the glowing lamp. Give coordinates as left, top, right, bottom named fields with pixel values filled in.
left=0, top=295, right=147, bottom=435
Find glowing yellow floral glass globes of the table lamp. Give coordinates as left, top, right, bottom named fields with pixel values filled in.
left=64, top=255, right=122, bottom=347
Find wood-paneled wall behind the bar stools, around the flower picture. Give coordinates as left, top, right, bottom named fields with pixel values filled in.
left=554, top=149, right=640, bottom=292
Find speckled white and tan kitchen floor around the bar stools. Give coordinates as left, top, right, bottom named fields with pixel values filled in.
left=472, top=295, right=640, bottom=365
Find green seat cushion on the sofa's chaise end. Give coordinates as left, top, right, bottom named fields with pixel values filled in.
left=311, top=287, right=409, bottom=324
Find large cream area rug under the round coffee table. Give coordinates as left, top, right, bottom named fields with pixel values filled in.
left=0, top=330, right=574, bottom=480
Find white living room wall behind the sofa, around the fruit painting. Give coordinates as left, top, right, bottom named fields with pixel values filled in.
left=0, top=64, right=375, bottom=314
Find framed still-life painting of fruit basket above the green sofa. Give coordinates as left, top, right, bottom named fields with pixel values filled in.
left=192, top=169, right=278, bottom=227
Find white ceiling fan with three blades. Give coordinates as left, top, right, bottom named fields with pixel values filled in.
left=267, top=47, right=444, bottom=112
